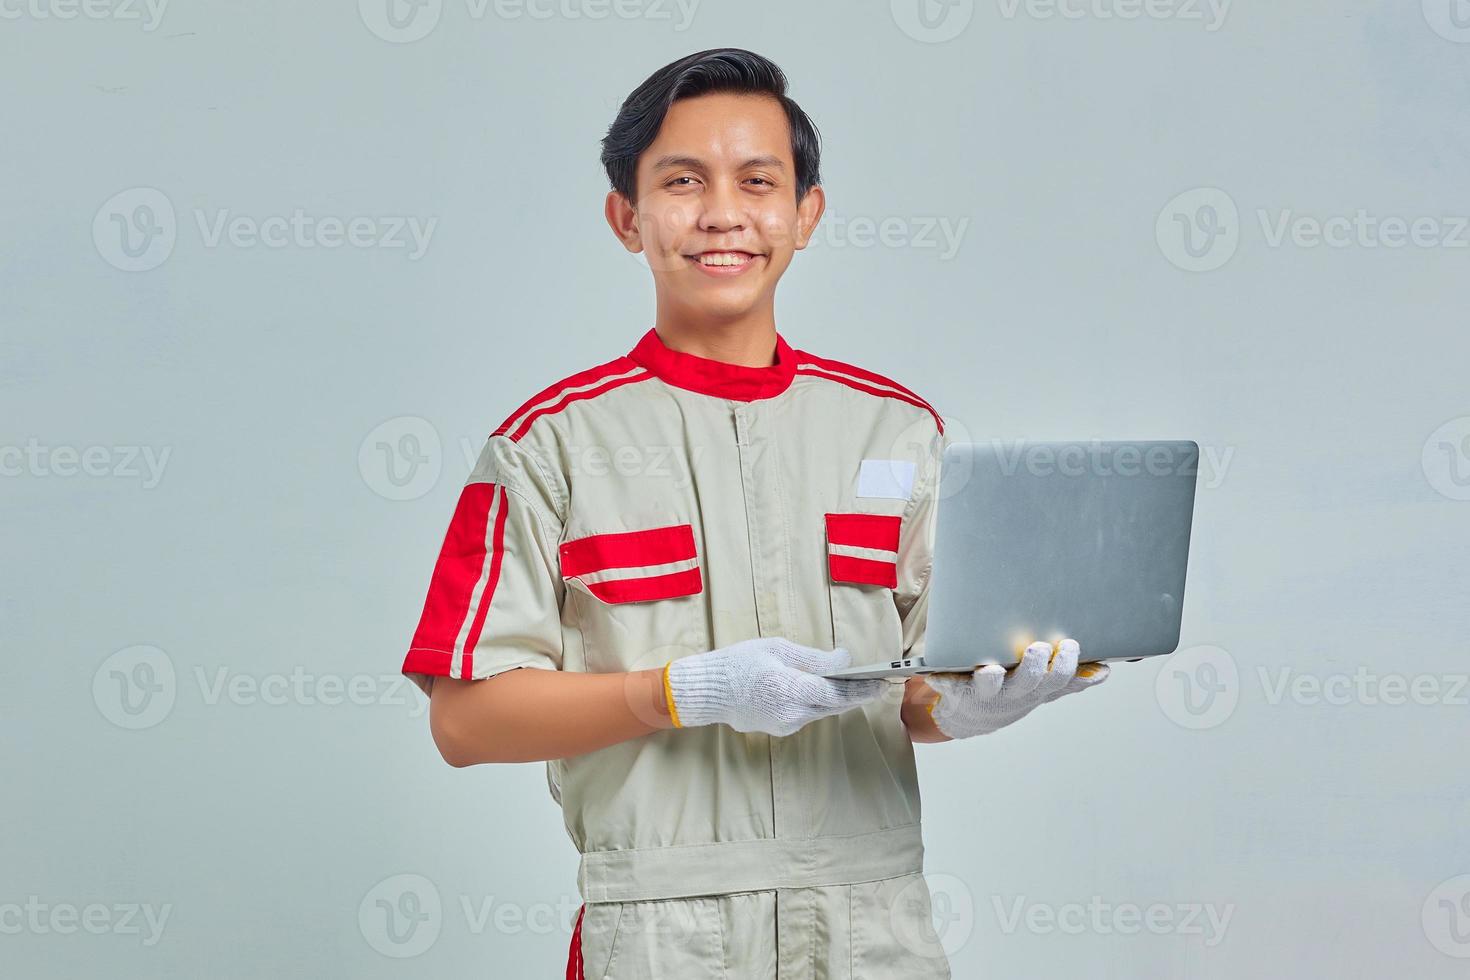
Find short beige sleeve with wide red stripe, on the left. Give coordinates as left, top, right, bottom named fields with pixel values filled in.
left=403, top=436, right=564, bottom=693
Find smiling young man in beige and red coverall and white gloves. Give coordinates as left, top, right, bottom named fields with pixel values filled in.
left=403, top=48, right=1107, bottom=980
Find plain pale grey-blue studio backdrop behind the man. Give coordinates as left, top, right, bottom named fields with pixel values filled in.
left=0, top=0, right=1470, bottom=980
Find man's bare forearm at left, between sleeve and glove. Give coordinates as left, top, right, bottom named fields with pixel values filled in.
left=429, top=667, right=673, bottom=765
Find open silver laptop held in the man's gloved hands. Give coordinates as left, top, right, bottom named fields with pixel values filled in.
left=825, top=441, right=1200, bottom=677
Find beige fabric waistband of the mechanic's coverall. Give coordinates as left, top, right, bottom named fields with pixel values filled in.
left=576, top=823, right=923, bottom=902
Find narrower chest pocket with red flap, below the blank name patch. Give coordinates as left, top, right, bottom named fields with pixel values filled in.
left=825, top=514, right=903, bottom=664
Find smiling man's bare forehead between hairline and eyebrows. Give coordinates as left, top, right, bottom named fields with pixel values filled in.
left=638, top=93, right=792, bottom=173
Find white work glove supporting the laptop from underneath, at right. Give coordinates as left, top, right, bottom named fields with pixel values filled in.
left=925, top=639, right=1111, bottom=739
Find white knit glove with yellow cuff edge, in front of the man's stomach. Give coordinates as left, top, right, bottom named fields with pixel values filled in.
left=663, top=636, right=885, bottom=735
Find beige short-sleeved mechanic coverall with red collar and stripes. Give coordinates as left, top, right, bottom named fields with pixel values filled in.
left=403, top=329, right=950, bottom=980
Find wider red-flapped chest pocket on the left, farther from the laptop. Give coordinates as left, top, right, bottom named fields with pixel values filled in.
left=560, top=523, right=709, bottom=671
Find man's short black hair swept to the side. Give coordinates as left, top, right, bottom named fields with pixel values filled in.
left=603, top=47, right=822, bottom=201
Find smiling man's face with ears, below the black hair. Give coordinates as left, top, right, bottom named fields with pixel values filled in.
left=607, top=93, right=822, bottom=319
